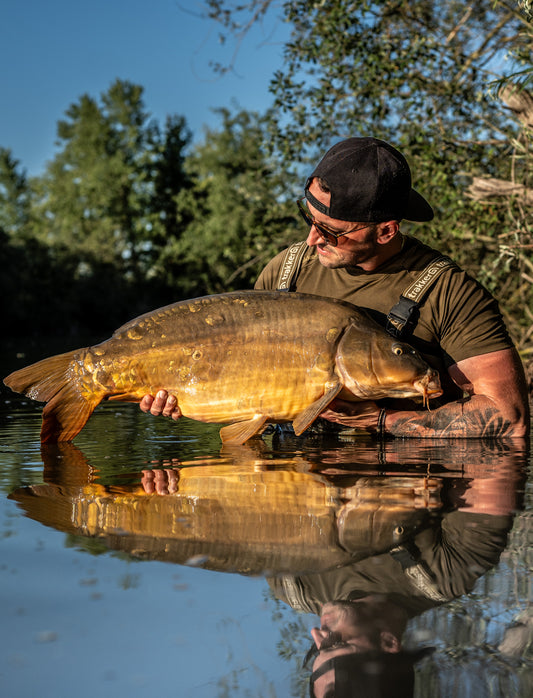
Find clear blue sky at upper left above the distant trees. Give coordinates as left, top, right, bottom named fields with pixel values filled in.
left=0, top=0, right=288, bottom=175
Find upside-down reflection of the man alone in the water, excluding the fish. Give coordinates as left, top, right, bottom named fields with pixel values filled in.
left=269, top=457, right=521, bottom=698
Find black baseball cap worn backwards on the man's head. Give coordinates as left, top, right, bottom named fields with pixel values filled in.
left=305, top=138, right=434, bottom=223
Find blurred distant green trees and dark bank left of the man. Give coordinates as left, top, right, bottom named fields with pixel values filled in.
left=0, top=80, right=301, bottom=336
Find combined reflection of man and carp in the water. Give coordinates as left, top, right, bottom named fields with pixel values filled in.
left=6, top=437, right=531, bottom=696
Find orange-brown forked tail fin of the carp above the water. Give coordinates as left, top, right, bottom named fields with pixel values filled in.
left=4, top=350, right=103, bottom=443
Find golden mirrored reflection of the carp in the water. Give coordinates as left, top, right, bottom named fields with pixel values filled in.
left=10, top=444, right=442, bottom=574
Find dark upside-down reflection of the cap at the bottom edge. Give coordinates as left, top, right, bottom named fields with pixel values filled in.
left=309, top=647, right=434, bottom=698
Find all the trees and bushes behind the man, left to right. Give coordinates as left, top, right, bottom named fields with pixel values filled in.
left=0, top=0, right=533, bottom=359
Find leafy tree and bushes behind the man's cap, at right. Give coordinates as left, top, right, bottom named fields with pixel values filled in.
left=197, top=0, right=533, bottom=344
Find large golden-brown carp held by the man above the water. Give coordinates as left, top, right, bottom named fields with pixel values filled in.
left=4, top=291, right=441, bottom=443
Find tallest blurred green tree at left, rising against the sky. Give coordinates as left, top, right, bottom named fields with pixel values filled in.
left=29, top=80, right=189, bottom=282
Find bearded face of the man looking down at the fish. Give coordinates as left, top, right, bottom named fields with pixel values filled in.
left=307, top=179, right=379, bottom=269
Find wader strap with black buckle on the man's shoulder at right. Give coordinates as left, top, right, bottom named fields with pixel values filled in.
left=386, top=257, right=456, bottom=339
